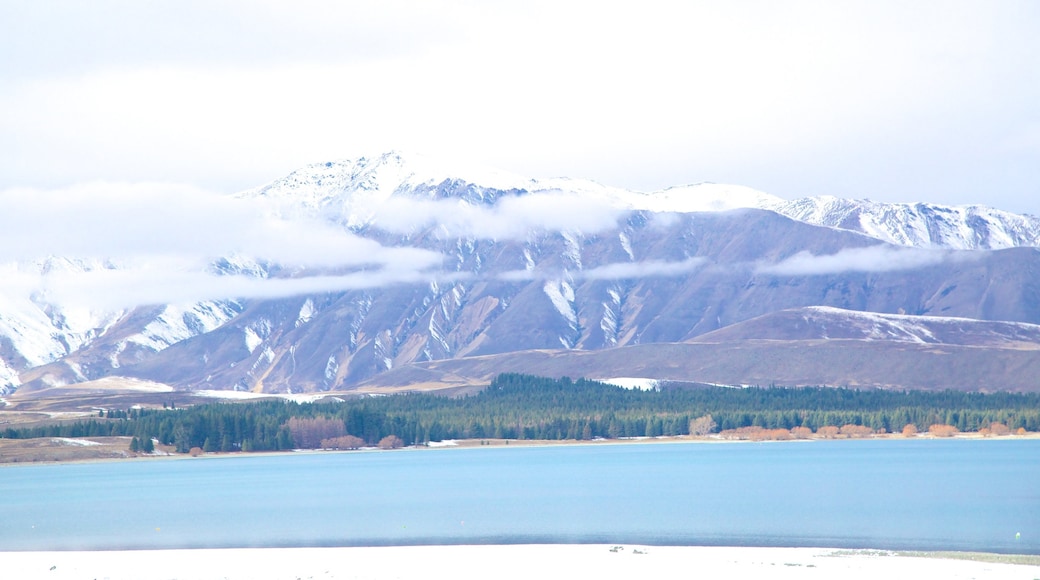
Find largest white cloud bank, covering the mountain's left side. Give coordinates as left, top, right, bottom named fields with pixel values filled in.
left=0, top=184, right=444, bottom=309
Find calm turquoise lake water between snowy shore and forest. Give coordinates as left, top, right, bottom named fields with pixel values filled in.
left=0, top=440, right=1040, bottom=554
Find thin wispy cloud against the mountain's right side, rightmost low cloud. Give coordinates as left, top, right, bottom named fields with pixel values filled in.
left=755, top=244, right=974, bottom=275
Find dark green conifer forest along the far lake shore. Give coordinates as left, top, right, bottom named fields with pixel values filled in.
left=0, top=374, right=1040, bottom=453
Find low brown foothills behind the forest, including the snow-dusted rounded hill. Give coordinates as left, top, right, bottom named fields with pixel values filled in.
left=353, top=307, right=1040, bottom=392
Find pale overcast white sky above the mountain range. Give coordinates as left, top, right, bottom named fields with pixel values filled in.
left=0, top=0, right=1040, bottom=215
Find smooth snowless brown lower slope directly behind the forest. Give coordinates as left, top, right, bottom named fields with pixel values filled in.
left=361, top=339, right=1040, bottom=392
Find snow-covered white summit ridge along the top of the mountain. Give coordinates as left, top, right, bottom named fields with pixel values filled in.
left=241, top=151, right=1040, bottom=249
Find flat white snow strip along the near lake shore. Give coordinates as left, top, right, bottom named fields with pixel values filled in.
left=0, top=545, right=1040, bottom=580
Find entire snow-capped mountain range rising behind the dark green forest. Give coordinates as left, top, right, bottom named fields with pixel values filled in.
left=0, top=153, right=1040, bottom=396
